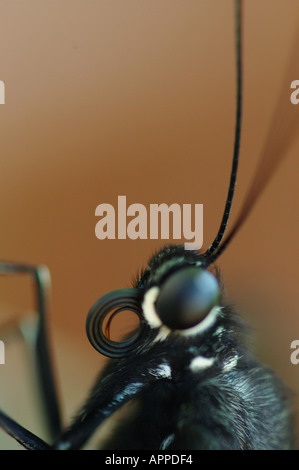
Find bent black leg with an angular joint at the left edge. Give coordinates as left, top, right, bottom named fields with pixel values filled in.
left=0, top=261, right=61, bottom=438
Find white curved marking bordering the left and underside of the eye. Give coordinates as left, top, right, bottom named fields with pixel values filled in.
left=142, top=286, right=222, bottom=341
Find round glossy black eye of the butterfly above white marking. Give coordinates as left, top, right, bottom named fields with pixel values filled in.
left=155, top=266, right=219, bottom=330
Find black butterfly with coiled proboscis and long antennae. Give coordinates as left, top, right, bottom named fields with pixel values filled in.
left=0, top=2, right=296, bottom=450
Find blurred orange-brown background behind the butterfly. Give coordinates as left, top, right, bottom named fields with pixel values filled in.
left=0, top=0, right=299, bottom=449
